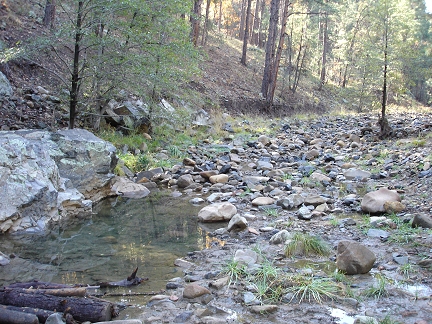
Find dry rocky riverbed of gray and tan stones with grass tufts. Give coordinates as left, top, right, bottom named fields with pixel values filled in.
left=112, top=114, right=432, bottom=324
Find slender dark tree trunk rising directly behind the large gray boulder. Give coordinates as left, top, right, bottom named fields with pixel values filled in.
left=69, top=1, right=84, bottom=129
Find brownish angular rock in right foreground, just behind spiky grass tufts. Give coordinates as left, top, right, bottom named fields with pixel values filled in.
left=336, top=241, right=376, bottom=275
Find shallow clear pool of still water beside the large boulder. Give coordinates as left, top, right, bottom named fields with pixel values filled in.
left=0, top=192, right=222, bottom=316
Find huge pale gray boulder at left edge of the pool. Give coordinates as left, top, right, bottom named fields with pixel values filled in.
left=0, top=129, right=117, bottom=232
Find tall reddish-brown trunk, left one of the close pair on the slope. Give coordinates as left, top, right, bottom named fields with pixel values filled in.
left=261, top=0, right=280, bottom=102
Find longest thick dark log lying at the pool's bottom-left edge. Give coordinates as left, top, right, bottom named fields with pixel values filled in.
left=0, top=289, right=117, bottom=322
